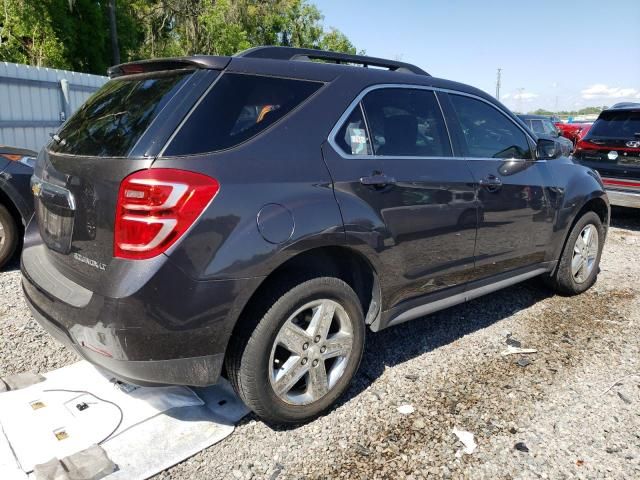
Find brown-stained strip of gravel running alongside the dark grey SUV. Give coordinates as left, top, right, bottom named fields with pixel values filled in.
left=313, top=289, right=636, bottom=478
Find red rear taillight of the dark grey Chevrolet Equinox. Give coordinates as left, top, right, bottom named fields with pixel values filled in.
left=113, top=168, right=220, bottom=260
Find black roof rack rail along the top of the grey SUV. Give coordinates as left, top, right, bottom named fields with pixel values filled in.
left=235, top=47, right=430, bottom=76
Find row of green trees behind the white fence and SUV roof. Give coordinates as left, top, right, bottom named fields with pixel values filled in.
left=0, top=0, right=356, bottom=74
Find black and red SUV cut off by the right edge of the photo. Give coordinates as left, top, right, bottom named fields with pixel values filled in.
left=575, top=103, right=640, bottom=208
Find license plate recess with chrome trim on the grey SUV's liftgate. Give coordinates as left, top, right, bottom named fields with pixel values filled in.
left=31, top=177, right=75, bottom=255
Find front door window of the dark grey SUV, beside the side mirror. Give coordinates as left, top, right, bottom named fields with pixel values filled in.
left=450, top=95, right=532, bottom=159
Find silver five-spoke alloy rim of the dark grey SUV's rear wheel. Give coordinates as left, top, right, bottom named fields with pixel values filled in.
left=269, top=299, right=353, bottom=405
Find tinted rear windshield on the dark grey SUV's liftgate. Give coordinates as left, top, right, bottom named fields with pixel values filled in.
left=50, top=71, right=191, bottom=157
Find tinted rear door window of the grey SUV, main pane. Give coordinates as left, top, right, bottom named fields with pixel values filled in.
left=363, top=88, right=452, bottom=157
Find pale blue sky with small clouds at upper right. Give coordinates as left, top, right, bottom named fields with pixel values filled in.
left=314, top=0, right=640, bottom=111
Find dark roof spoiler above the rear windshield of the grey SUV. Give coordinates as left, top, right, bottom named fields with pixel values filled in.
left=107, top=55, right=231, bottom=78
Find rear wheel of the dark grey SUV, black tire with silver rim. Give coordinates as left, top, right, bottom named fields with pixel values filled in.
left=227, top=277, right=365, bottom=424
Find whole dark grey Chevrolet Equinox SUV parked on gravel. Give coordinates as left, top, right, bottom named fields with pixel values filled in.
left=22, top=47, right=609, bottom=423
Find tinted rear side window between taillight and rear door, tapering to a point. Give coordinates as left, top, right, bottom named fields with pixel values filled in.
left=164, top=73, right=322, bottom=156
